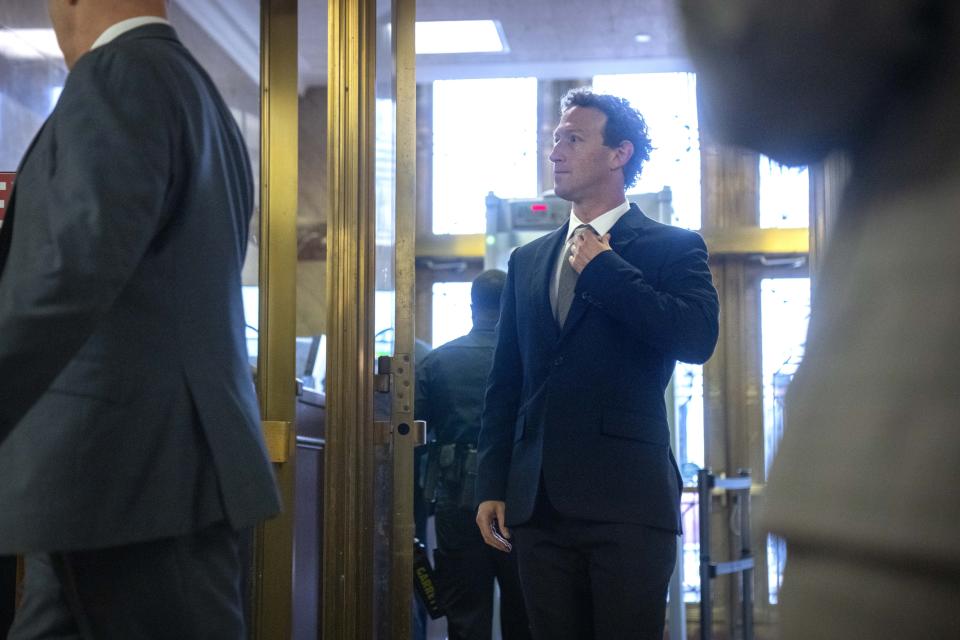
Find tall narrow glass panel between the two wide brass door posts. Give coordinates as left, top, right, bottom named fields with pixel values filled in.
left=292, top=0, right=329, bottom=640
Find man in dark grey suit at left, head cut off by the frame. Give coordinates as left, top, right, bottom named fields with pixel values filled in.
left=0, top=0, right=279, bottom=640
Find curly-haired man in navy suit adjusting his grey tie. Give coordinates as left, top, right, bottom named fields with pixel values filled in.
left=477, top=90, right=718, bottom=640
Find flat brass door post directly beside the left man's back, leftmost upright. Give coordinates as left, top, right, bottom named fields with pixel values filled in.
left=250, top=0, right=299, bottom=640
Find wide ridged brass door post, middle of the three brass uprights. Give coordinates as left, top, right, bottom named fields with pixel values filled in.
left=323, top=0, right=376, bottom=640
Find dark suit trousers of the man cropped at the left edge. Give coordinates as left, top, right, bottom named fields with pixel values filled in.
left=9, top=525, right=246, bottom=640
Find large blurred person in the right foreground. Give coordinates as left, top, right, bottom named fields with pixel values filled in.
left=681, top=0, right=960, bottom=640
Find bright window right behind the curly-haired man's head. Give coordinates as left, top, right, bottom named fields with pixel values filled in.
left=593, top=73, right=700, bottom=229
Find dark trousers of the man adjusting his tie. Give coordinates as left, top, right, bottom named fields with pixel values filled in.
left=511, top=490, right=677, bottom=640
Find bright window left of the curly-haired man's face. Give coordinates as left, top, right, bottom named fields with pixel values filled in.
left=433, top=78, right=538, bottom=234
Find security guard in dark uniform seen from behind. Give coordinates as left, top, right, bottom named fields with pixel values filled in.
left=415, top=269, right=531, bottom=640
